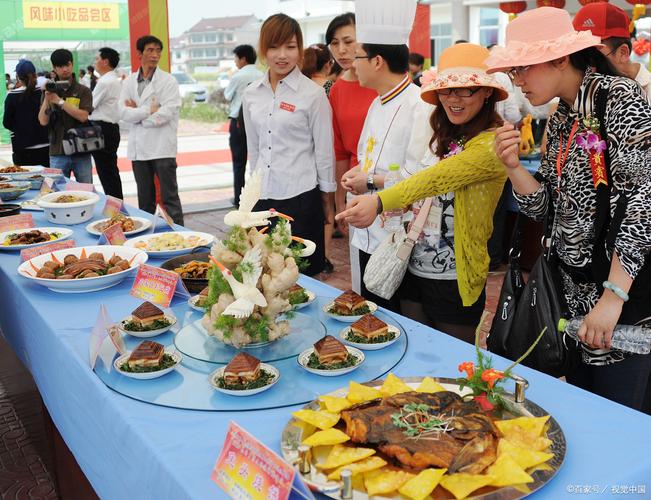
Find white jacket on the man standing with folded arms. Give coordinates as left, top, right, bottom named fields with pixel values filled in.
left=120, top=68, right=181, bottom=161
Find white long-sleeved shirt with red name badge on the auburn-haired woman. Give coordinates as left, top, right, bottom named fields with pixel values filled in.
left=242, top=67, right=336, bottom=200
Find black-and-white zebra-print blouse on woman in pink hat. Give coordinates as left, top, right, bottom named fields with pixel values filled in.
left=514, top=71, right=651, bottom=365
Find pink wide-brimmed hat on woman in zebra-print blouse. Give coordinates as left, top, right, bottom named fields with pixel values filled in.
left=485, top=7, right=602, bottom=73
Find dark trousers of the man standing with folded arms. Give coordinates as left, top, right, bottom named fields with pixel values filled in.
left=131, top=158, right=183, bottom=225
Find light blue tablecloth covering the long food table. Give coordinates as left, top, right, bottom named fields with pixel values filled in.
left=0, top=197, right=651, bottom=500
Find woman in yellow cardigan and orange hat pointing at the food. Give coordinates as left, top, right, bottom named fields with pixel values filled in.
left=338, top=43, right=507, bottom=343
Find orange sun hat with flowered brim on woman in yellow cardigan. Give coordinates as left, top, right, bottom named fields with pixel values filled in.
left=420, top=43, right=509, bottom=105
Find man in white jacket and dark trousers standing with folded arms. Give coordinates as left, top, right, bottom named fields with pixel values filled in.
left=120, top=35, right=183, bottom=225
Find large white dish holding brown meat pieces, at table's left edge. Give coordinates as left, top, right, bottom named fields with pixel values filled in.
left=18, top=245, right=148, bottom=293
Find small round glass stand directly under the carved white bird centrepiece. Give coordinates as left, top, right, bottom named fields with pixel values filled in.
left=174, top=312, right=326, bottom=365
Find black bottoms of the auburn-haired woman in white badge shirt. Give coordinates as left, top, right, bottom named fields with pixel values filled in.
left=253, top=186, right=325, bottom=276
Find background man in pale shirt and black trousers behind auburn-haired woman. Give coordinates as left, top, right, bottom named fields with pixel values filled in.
left=224, top=45, right=262, bottom=207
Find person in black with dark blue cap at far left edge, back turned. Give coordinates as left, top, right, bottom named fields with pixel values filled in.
left=2, top=59, right=50, bottom=167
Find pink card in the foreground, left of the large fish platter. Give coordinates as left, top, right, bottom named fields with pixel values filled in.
left=210, top=422, right=295, bottom=500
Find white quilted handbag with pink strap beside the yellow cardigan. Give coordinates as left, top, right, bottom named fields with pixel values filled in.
left=364, top=198, right=432, bottom=300
